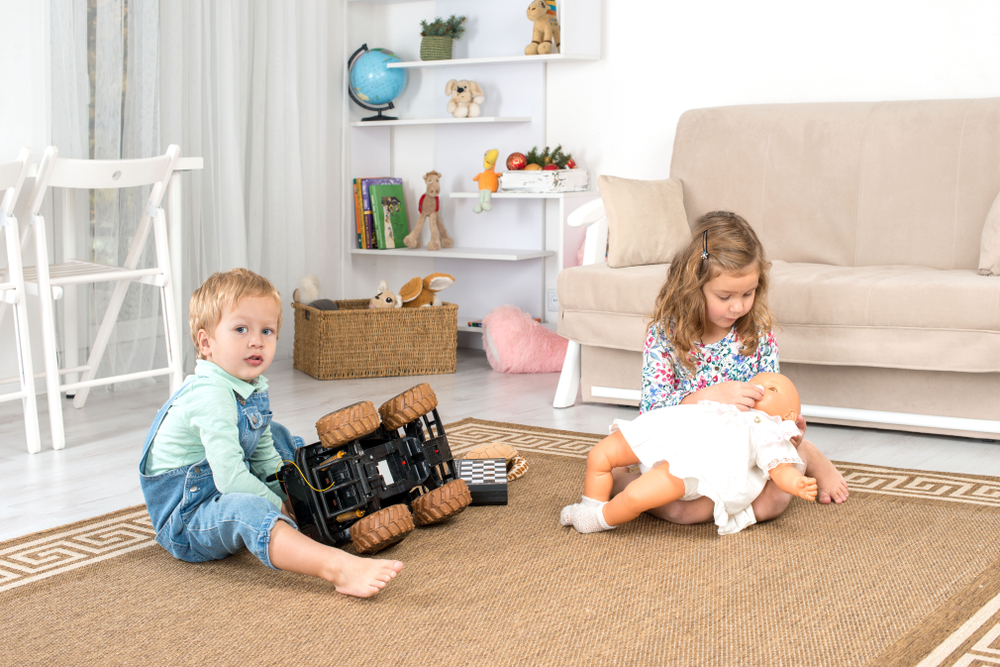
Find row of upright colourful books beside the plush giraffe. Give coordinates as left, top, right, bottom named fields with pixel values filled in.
left=354, top=178, right=410, bottom=250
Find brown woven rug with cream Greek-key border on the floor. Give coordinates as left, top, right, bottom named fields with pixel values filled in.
left=0, top=419, right=1000, bottom=667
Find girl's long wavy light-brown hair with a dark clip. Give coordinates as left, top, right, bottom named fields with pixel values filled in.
left=651, top=211, right=773, bottom=372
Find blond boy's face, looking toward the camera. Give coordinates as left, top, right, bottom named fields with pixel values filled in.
left=198, top=296, right=280, bottom=382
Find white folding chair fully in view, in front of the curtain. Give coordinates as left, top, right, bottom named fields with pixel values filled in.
left=24, top=145, right=183, bottom=449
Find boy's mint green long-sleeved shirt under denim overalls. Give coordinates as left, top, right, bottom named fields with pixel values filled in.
left=146, top=359, right=284, bottom=508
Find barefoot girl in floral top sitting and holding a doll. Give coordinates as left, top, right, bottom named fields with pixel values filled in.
left=612, top=211, right=848, bottom=523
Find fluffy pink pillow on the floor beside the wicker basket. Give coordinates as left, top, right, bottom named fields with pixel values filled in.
left=483, top=306, right=569, bottom=373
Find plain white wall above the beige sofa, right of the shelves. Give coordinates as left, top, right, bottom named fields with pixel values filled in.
left=547, top=0, right=1000, bottom=179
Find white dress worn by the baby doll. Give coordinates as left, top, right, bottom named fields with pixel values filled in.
left=612, top=401, right=805, bottom=535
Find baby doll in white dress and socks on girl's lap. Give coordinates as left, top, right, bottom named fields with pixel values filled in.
left=559, top=373, right=817, bottom=535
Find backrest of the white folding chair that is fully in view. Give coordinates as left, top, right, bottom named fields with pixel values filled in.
left=29, top=144, right=180, bottom=216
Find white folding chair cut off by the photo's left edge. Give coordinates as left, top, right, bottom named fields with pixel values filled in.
left=0, top=148, right=42, bottom=454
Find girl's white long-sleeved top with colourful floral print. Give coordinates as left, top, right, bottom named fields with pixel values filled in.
left=639, top=323, right=779, bottom=413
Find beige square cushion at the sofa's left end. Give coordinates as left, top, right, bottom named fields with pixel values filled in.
left=597, top=176, right=691, bottom=268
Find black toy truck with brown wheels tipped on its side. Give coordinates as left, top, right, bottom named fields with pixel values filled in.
left=277, top=383, right=472, bottom=553
